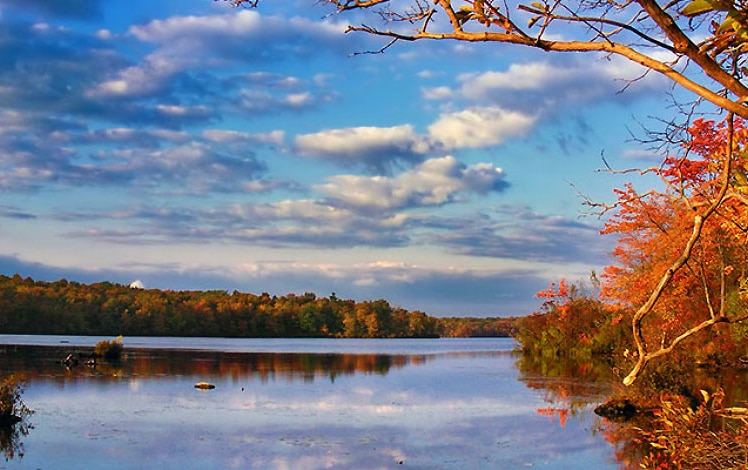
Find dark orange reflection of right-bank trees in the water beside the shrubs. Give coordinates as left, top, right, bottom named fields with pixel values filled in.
left=516, top=355, right=748, bottom=469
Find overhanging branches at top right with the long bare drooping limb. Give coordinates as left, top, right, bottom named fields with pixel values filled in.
left=231, top=0, right=748, bottom=384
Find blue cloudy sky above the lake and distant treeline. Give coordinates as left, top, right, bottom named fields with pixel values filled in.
left=0, top=0, right=672, bottom=316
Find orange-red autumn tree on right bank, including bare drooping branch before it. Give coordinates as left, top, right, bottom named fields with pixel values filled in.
left=603, top=117, right=748, bottom=384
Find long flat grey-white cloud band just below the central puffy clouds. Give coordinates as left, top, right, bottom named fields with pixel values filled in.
left=52, top=199, right=411, bottom=249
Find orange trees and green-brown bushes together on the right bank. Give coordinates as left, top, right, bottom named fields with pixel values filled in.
left=516, top=118, right=748, bottom=368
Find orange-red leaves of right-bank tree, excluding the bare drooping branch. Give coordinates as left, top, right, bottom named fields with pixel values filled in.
left=601, top=119, right=748, bottom=356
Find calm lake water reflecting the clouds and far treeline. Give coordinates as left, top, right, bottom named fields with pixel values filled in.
left=0, top=335, right=618, bottom=469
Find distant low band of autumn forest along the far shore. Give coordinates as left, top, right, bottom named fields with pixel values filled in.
left=0, top=274, right=514, bottom=338
